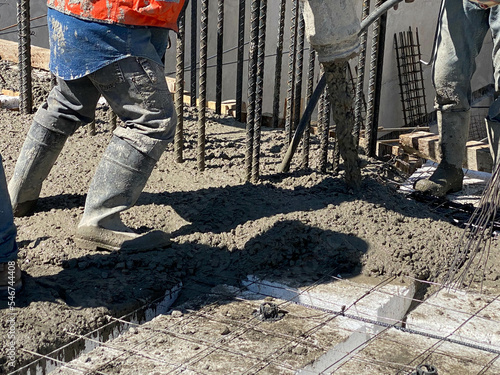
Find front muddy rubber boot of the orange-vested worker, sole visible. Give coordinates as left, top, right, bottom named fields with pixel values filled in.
left=75, top=136, right=171, bottom=252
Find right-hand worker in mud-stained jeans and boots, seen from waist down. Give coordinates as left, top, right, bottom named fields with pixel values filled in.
left=415, top=0, right=500, bottom=197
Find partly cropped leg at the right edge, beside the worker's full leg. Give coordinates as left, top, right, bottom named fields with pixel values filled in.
left=486, top=6, right=500, bottom=166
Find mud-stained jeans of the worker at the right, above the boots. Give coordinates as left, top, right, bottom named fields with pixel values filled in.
left=433, top=0, right=500, bottom=117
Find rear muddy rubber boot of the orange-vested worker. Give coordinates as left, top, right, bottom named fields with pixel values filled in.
left=8, top=122, right=68, bottom=217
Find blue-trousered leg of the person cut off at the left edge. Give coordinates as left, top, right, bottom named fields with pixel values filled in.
left=0, top=155, right=21, bottom=297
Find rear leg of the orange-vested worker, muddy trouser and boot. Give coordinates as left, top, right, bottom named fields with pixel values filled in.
left=9, top=78, right=100, bottom=216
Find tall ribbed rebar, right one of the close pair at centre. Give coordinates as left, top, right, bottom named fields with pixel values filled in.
left=252, top=0, right=267, bottom=182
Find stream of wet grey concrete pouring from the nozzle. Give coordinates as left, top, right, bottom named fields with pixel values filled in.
left=323, top=60, right=361, bottom=189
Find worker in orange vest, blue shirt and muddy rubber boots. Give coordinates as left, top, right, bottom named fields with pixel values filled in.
left=9, top=0, right=187, bottom=251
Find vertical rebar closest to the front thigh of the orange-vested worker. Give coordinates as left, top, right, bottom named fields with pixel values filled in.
left=174, top=14, right=186, bottom=163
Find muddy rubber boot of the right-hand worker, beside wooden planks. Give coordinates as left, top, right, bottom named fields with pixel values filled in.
left=414, top=111, right=470, bottom=197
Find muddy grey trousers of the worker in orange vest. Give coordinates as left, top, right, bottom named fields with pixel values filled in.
left=34, top=57, right=177, bottom=160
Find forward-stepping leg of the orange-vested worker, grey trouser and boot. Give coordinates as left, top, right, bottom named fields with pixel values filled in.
left=77, top=57, right=177, bottom=250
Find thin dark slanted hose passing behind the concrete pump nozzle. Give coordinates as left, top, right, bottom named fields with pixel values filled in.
left=278, top=0, right=403, bottom=173
